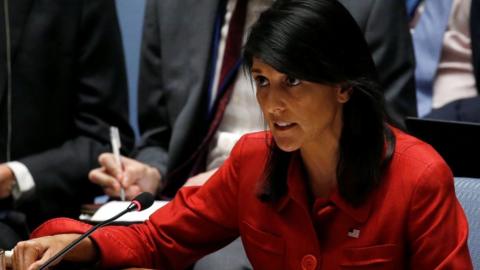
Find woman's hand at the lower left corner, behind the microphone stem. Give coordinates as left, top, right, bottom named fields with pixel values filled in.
left=11, top=234, right=97, bottom=270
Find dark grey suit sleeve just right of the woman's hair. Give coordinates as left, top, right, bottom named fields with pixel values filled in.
left=365, top=0, right=417, bottom=126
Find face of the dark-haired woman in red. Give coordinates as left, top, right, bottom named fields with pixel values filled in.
left=252, top=58, right=350, bottom=152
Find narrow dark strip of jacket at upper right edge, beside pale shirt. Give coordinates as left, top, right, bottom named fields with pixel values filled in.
left=470, top=0, right=480, bottom=93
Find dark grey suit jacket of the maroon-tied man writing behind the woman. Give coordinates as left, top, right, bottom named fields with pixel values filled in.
left=136, top=0, right=416, bottom=196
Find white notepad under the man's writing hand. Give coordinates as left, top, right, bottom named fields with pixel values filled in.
left=87, top=201, right=168, bottom=223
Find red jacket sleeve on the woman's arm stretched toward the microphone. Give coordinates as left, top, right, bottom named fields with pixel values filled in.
left=32, top=136, right=246, bottom=269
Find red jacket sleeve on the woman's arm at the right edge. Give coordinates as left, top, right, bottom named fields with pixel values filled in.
left=408, top=162, right=473, bottom=269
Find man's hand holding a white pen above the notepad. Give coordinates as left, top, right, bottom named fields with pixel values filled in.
left=88, top=153, right=161, bottom=200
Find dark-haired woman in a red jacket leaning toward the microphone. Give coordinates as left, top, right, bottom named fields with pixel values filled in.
left=9, top=0, right=472, bottom=269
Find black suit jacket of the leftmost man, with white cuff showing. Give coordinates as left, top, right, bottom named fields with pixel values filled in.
left=0, top=0, right=133, bottom=228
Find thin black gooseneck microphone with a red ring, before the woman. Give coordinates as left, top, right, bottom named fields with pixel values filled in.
left=40, top=192, right=154, bottom=270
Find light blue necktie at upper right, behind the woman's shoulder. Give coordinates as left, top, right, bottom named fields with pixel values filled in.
left=413, top=0, right=452, bottom=117
